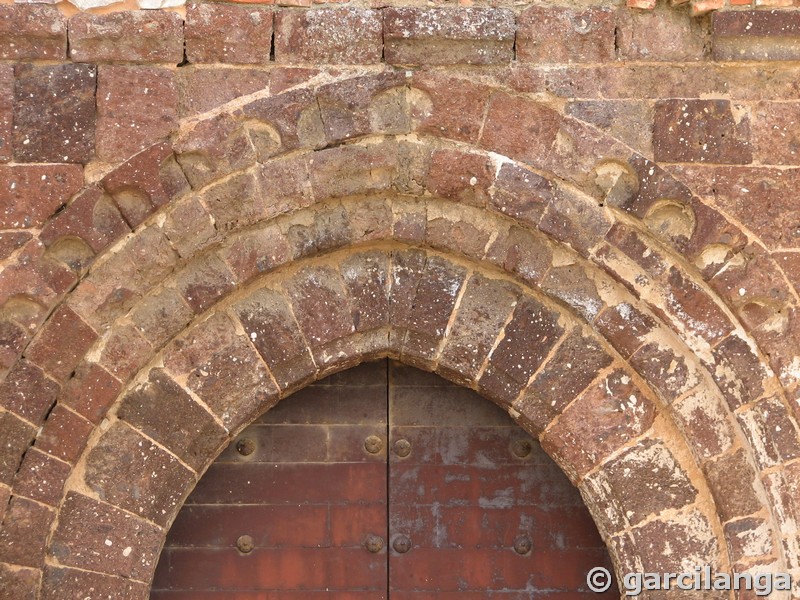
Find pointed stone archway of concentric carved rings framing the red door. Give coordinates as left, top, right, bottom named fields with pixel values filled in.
left=2, top=62, right=797, bottom=597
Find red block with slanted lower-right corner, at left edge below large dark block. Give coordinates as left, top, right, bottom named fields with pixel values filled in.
left=0, top=165, right=83, bottom=229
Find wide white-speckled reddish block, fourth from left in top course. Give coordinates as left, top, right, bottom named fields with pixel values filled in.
left=275, top=8, right=383, bottom=65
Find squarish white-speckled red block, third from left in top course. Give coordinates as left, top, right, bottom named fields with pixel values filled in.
left=185, top=3, right=272, bottom=64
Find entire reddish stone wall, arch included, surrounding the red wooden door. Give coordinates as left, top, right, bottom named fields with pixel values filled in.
left=0, top=2, right=800, bottom=600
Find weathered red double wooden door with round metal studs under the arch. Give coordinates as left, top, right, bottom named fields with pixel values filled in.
left=151, top=361, right=615, bottom=600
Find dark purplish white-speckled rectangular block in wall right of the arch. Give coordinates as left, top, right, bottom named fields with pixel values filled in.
left=653, top=100, right=753, bottom=164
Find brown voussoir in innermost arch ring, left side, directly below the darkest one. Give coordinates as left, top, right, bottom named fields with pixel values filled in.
left=83, top=421, right=197, bottom=526
